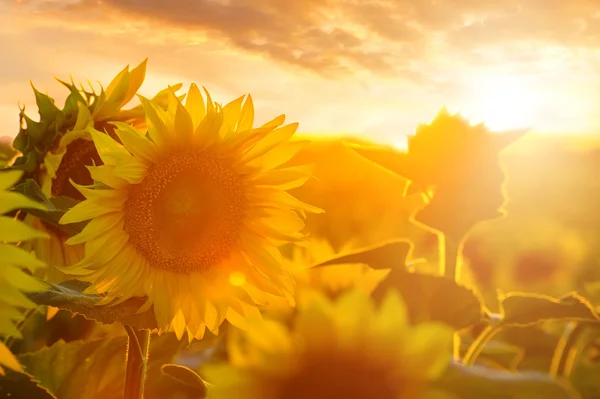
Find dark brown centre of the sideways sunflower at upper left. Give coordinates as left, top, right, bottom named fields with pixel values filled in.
left=52, top=139, right=102, bottom=201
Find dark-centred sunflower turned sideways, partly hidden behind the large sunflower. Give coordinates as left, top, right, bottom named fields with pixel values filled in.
left=14, top=60, right=178, bottom=282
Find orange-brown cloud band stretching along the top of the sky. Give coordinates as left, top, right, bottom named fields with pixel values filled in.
left=11, top=0, right=600, bottom=82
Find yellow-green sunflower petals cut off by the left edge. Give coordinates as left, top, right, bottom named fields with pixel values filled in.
left=0, top=171, right=48, bottom=374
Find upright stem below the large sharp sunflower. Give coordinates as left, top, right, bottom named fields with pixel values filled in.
left=124, top=326, right=150, bottom=399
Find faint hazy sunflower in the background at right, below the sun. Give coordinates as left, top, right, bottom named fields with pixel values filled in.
left=461, top=218, right=589, bottom=296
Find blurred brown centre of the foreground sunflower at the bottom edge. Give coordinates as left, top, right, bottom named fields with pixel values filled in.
left=276, top=353, right=421, bottom=399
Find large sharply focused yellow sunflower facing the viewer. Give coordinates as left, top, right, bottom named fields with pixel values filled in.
left=60, top=85, right=320, bottom=338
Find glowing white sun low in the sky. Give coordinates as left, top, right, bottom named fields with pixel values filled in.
left=461, top=75, right=539, bottom=131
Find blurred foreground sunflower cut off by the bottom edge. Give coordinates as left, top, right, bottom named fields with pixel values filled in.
left=202, top=290, right=452, bottom=399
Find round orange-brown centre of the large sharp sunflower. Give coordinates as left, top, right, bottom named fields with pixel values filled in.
left=124, top=152, right=246, bottom=273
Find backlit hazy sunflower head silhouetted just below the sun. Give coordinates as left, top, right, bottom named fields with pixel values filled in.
left=355, top=108, right=526, bottom=243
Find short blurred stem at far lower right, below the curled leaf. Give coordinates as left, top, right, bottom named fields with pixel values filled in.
left=550, top=321, right=588, bottom=377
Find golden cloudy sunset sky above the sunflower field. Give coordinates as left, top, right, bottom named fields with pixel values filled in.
left=0, top=0, right=600, bottom=146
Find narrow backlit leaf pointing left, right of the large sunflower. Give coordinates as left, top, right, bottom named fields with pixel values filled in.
left=314, top=239, right=413, bottom=270
